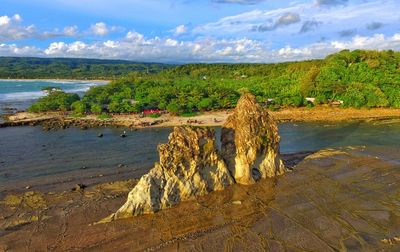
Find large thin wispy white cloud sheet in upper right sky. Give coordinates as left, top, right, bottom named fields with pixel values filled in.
left=192, top=0, right=400, bottom=44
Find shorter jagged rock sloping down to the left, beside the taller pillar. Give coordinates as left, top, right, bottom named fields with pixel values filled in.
left=110, top=126, right=234, bottom=219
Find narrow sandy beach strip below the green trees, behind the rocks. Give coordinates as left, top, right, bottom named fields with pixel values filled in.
left=0, top=106, right=400, bottom=129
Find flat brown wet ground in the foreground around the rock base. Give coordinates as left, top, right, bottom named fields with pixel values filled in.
left=0, top=147, right=400, bottom=251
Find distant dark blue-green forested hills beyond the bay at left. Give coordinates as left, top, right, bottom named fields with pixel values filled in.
left=0, top=57, right=172, bottom=80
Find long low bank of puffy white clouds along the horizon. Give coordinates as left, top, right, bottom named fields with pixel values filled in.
left=0, top=31, right=400, bottom=63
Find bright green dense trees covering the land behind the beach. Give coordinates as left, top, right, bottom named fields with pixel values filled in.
left=28, top=50, right=400, bottom=114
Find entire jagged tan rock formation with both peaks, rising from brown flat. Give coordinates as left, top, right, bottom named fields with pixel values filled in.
left=109, top=94, right=285, bottom=221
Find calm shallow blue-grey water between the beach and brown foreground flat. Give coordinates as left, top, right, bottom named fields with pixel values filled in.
left=0, top=121, right=400, bottom=192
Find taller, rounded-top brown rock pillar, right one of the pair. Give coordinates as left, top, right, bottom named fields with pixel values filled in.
left=221, top=93, right=285, bottom=184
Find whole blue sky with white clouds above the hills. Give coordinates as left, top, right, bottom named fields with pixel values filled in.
left=0, top=0, right=400, bottom=63
